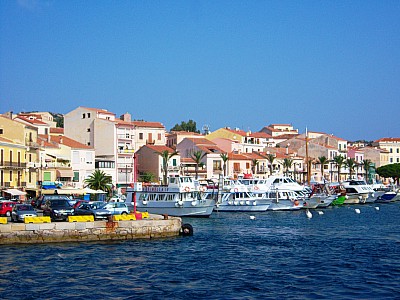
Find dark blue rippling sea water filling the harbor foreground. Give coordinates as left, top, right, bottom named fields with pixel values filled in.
left=0, top=203, right=400, bottom=299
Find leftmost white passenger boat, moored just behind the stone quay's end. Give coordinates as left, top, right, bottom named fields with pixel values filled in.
left=126, top=176, right=215, bottom=217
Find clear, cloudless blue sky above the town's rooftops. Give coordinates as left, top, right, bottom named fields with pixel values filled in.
left=0, top=0, right=400, bottom=140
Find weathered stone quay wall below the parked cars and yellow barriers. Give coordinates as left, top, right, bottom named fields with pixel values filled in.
left=0, top=217, right=182, bottom=245
